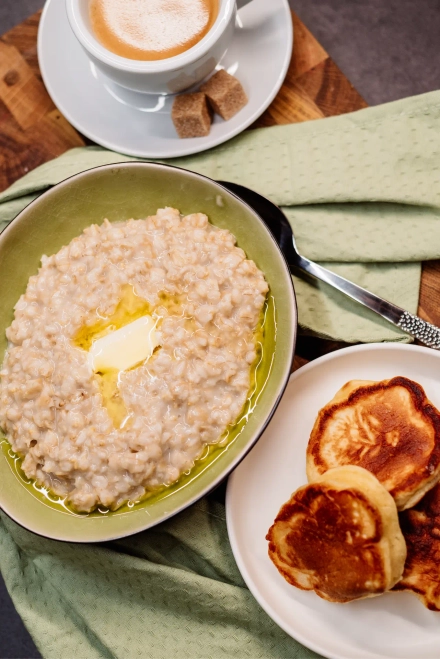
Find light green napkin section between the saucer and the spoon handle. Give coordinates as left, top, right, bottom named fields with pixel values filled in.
left=0, top=92, right=440, bottom=343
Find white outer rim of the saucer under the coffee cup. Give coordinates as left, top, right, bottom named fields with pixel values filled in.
left=37, top=0, right=294, bottom=158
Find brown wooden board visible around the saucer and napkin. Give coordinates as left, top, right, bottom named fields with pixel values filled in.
left=0, top=12, right=440, bottom=366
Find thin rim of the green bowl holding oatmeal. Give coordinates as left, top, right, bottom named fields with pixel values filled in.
left=0, top=160, right=298, bottom=544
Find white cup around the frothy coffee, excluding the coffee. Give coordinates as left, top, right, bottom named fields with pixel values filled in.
left=66, top=0, right=250, bottom=94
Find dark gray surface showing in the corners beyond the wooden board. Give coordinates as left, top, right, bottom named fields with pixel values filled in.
left=0, top=0, right=440, bottom=659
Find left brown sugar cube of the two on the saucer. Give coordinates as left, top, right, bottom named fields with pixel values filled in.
left=171, top=92, right=211, bottom=137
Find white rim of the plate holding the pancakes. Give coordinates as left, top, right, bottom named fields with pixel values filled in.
left=225, top=342, right=440, bottom=659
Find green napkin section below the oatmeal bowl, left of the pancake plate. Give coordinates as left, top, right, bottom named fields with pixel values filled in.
left=0, top=499, right=324, bottom=659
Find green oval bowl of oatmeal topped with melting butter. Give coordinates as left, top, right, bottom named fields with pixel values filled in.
left=0, top=163, right=297, bottom=542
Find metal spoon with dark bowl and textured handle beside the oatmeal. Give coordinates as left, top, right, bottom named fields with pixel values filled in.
left=218, top=181, right=440, bottom=350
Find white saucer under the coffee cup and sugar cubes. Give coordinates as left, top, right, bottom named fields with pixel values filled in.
left=38, top=0, right=293, bottom=158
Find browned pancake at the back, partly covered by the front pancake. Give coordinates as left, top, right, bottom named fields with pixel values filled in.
left=307, top=377, right=440, bottom=510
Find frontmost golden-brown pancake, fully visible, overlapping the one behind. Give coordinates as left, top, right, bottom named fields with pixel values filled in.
left=266, top=466, right=406, bottom=602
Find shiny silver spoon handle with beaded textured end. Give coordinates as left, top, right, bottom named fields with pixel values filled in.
left=291, top=254, right=440, bottom=350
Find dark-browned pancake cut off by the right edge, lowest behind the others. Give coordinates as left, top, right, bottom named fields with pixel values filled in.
left=395, top=484, right=440, bottom=611
